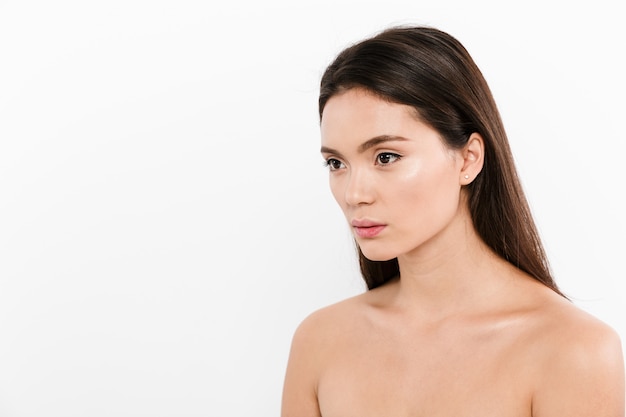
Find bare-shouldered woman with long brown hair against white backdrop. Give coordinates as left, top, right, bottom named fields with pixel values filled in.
left=282, top=27, right=624, bottom=417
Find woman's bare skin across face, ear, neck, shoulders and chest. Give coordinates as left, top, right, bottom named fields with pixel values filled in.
left=282, top=90, right=625, bottom=417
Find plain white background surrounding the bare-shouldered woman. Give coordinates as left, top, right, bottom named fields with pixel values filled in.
left=0, top=0, right=626, bottom=417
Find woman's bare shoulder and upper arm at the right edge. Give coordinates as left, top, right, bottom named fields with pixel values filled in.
left=531, top=294, right=625, bottom=417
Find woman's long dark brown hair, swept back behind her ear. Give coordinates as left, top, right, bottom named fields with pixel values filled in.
left=319, top=27, right=563, bottom=295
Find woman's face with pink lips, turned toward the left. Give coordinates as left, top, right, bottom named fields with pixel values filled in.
left=321, top=89, right=467, bottom=261
